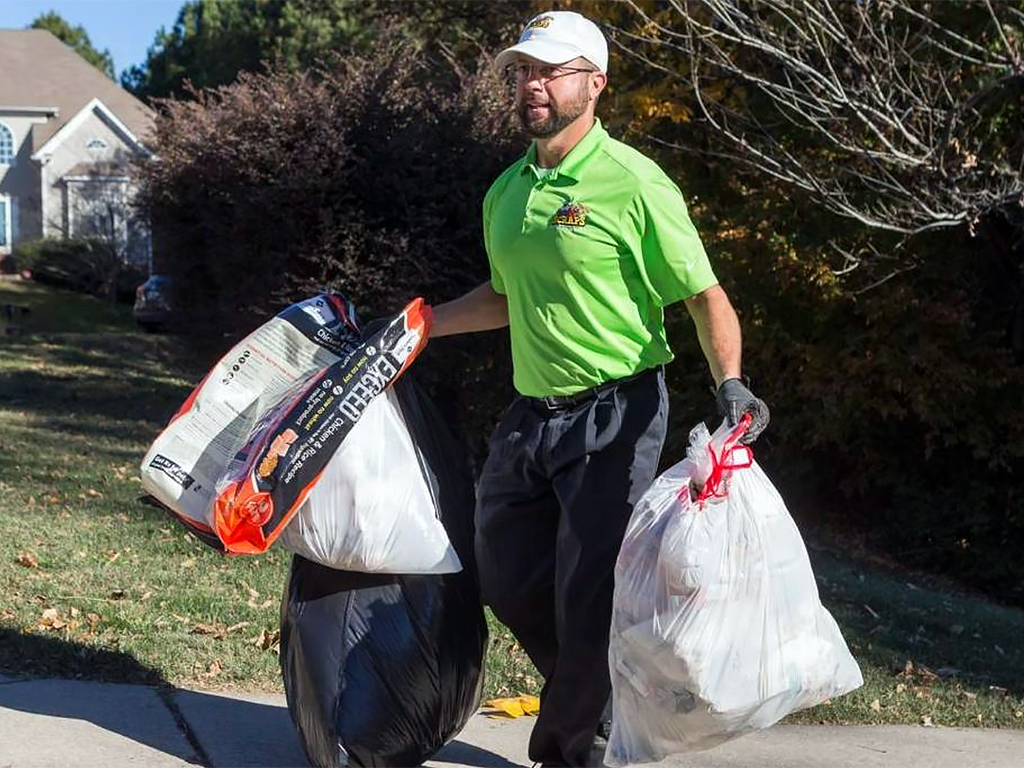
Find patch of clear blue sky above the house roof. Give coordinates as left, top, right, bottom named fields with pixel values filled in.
left=0, top=0, right=184, bottom=78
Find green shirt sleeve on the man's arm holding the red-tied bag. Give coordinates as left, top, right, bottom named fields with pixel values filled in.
left=629, top=175, right=718, bottom=306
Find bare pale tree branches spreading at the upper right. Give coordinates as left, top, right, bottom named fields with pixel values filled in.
left=610, top=0, right=1024, bottom=239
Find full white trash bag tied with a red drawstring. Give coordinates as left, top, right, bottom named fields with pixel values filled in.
left=605, top=417, right=863, bottom=766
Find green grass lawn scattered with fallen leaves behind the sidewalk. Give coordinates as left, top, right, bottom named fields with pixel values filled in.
left=0, top=283, right=1024, bottom=727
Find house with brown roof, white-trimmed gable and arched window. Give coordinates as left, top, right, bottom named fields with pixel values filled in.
left=0, top=30, right=154, bottom=266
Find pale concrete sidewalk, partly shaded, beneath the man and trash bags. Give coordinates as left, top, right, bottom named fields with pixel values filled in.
left=0, top=678, right=1024, bottom=768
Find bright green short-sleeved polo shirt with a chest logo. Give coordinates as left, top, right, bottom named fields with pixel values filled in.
left=483, top=121, right=717, bottom=397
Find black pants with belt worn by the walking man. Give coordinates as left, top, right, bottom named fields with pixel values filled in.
left=476, top=369, right=669, bottom=766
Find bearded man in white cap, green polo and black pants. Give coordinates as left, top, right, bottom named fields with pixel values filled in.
left=432, top=12, right=768, bottom=766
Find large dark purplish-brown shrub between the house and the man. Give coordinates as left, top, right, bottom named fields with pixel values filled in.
left=140, top=36, right=522, bottom=456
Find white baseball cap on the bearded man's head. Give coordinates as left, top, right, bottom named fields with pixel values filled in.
left=495, top=10, right=608, bottom=72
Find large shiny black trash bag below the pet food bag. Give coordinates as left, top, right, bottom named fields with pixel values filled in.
left=281, top=374, right=487, bottom=766
